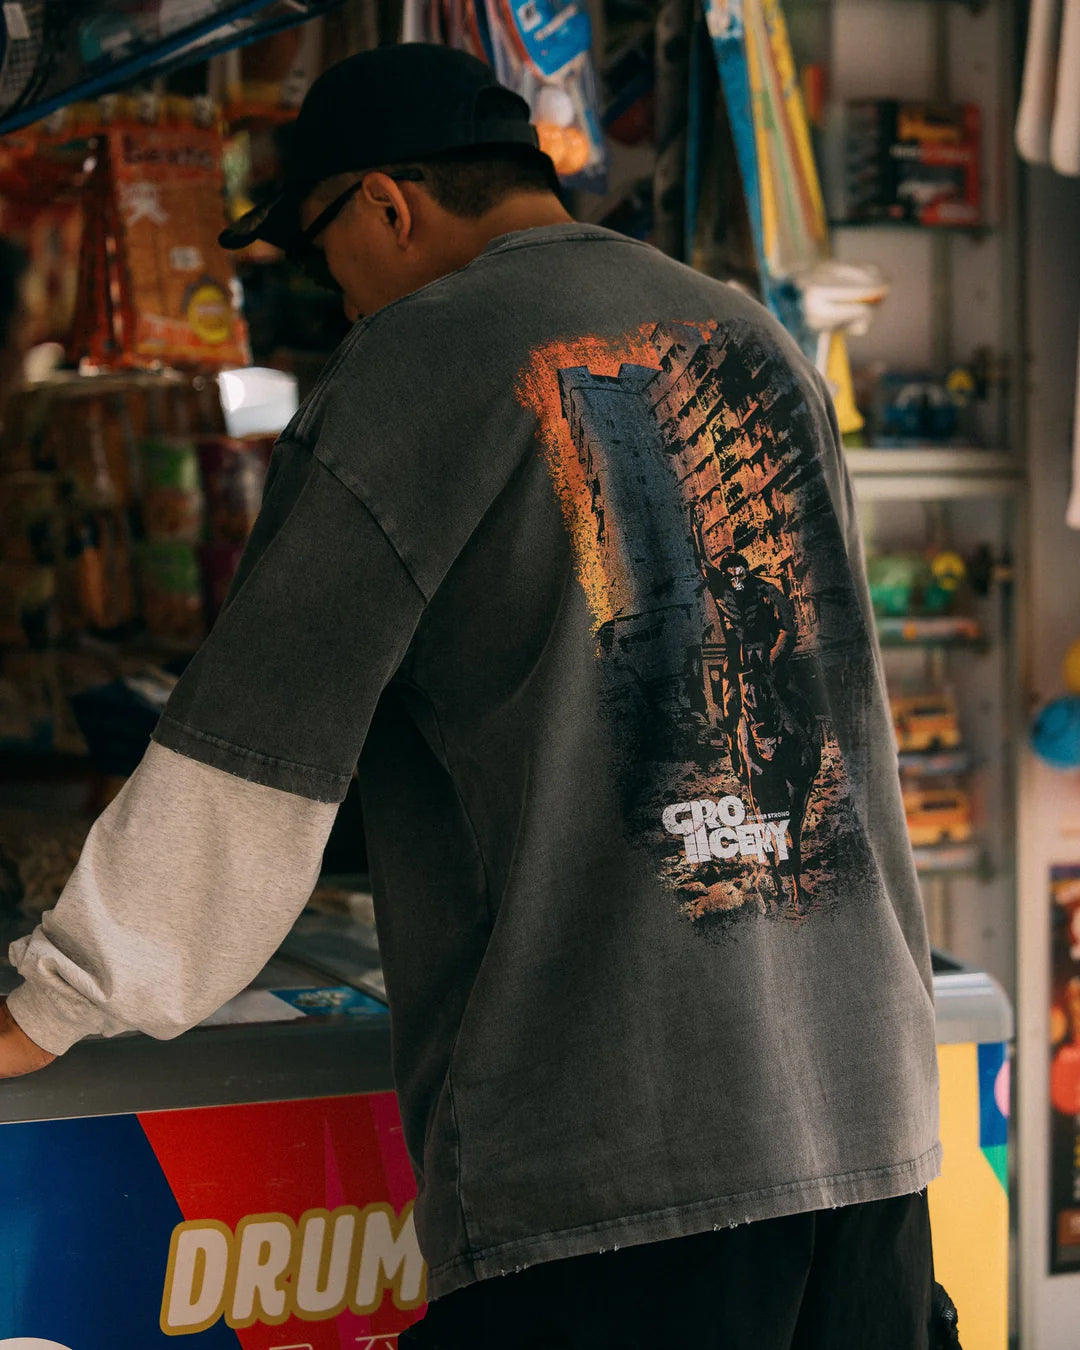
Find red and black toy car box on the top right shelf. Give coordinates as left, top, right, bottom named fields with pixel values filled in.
left=844, top=99, right=981, bottom=227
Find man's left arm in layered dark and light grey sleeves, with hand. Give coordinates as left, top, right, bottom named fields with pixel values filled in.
left=0, top=446, right=425, bottom=1073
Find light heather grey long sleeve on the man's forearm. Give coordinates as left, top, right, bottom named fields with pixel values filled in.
left=8, top=745, right=338, bottom=1054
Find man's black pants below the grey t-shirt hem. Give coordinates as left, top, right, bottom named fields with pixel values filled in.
left=398, top=1195, right=956, bottom=1350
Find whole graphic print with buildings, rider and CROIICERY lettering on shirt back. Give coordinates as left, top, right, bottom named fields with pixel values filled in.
left=518, top=323, right=872, bottom=933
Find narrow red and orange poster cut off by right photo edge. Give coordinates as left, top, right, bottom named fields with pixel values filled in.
left=1050, top=864, right=1080, bottom=1274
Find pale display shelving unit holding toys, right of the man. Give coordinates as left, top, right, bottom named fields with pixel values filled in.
left=790, top=0, right=1025, bottom=995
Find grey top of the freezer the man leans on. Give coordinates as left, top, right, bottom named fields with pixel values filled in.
left=0, top=911, right=1013, bottom=1125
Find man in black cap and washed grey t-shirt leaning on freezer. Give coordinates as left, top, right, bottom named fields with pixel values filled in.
left=0, top=46, right=940, bottom=1350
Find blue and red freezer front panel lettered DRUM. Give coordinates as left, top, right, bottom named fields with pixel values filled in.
left=0, top=1092, right=425, bottom=1350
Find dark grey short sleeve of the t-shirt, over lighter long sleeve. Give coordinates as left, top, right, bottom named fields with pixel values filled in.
left=154, top=441, right=424, bottom=802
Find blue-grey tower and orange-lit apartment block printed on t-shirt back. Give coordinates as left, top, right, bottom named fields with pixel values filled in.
left=559, top=324, right=851, bottom=745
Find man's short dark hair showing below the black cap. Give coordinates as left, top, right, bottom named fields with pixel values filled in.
left=316, top=144, right=559, bottom=220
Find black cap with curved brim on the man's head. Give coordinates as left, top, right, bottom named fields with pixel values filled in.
left=219, top=42, right=541, bottom=251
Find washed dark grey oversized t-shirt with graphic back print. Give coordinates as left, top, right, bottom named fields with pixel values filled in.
left=155, top=225, right=940, bottom=1296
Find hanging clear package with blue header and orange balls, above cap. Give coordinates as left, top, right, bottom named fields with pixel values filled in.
left=475, top=0, right=608, bottom=192
